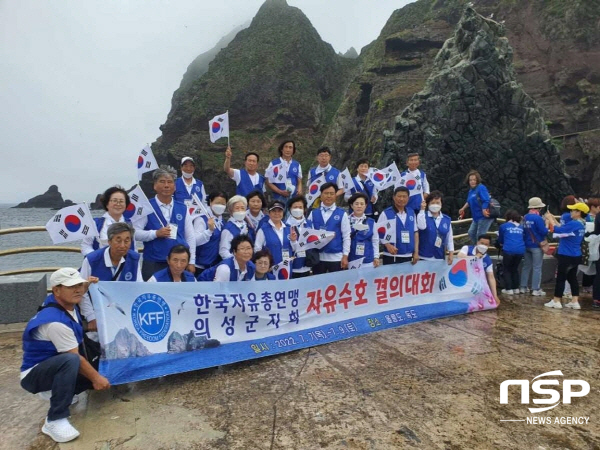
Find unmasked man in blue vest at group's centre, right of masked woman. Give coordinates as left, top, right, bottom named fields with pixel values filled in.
left=308, top=183, right=352, bottom=275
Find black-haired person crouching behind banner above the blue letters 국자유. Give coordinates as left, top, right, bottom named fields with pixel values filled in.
left=198, top=234, right=256, bottom=281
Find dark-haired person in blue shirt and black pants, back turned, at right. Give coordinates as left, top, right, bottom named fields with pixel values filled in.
left=498, top=209, right=525, bottom=295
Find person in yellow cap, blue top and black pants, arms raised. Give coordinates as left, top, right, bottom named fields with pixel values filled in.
left=544, top=203, right=590, bottom=309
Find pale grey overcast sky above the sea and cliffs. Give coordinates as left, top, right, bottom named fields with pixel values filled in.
left=0, top=0, right=410, bottom=203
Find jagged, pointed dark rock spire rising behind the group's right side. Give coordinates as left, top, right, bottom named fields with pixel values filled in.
left=382, top=7, right=572, bottom=211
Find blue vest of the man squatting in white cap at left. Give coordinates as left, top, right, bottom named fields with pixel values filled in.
left=21, top=294, right=83, bottom=372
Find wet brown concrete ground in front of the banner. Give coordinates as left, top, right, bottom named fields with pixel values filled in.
left=0, top=289, right=600, bottom=450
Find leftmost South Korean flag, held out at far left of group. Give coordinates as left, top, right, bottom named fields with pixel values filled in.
left=46, top=203, right=98, bottom=244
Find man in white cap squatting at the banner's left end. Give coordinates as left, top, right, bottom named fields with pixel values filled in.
left=21, top=267, right=110, bottom=443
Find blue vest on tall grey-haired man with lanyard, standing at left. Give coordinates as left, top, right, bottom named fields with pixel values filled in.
left=144, top=197, right=188, bottom=263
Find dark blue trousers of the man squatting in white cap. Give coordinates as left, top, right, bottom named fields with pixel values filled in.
left=21, top=353, right=92, bottom=420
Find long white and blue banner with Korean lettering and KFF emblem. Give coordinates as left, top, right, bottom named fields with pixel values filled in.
left=90, top=258, right=497, bottom=384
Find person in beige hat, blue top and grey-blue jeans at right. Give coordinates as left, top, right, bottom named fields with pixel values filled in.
left=519, top=197, right=548, bottom=296
